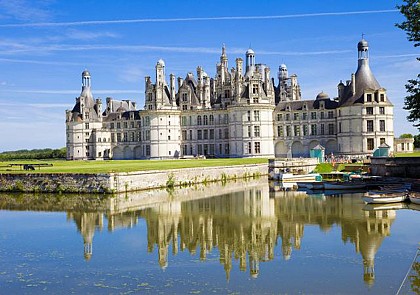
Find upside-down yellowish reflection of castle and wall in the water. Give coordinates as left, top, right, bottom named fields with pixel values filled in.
left=0, top=180, right=404, bottom=285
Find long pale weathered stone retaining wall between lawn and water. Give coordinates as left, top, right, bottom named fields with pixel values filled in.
left=0, top=164, right=267, bottom=193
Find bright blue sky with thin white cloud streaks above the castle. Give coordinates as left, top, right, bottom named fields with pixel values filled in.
left=0, top=0, right=420, bottom=152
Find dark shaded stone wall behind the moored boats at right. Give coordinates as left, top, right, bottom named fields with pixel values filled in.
left=370, top=157, right=420, bottom=178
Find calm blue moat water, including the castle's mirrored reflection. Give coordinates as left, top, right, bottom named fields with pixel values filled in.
left=0, top=179, right=420, bottom=294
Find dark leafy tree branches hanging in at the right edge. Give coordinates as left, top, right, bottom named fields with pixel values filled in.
left=396, top=0, right=420, bottom=130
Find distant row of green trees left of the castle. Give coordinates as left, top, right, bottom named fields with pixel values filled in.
left=0, top=147, right=67, bottom=161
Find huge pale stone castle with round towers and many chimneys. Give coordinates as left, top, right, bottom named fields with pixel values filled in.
left=66, top=39, right=394, bottom=160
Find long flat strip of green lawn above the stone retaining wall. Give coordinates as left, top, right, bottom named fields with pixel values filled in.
left=0, top=158, right=268, bottom=173
